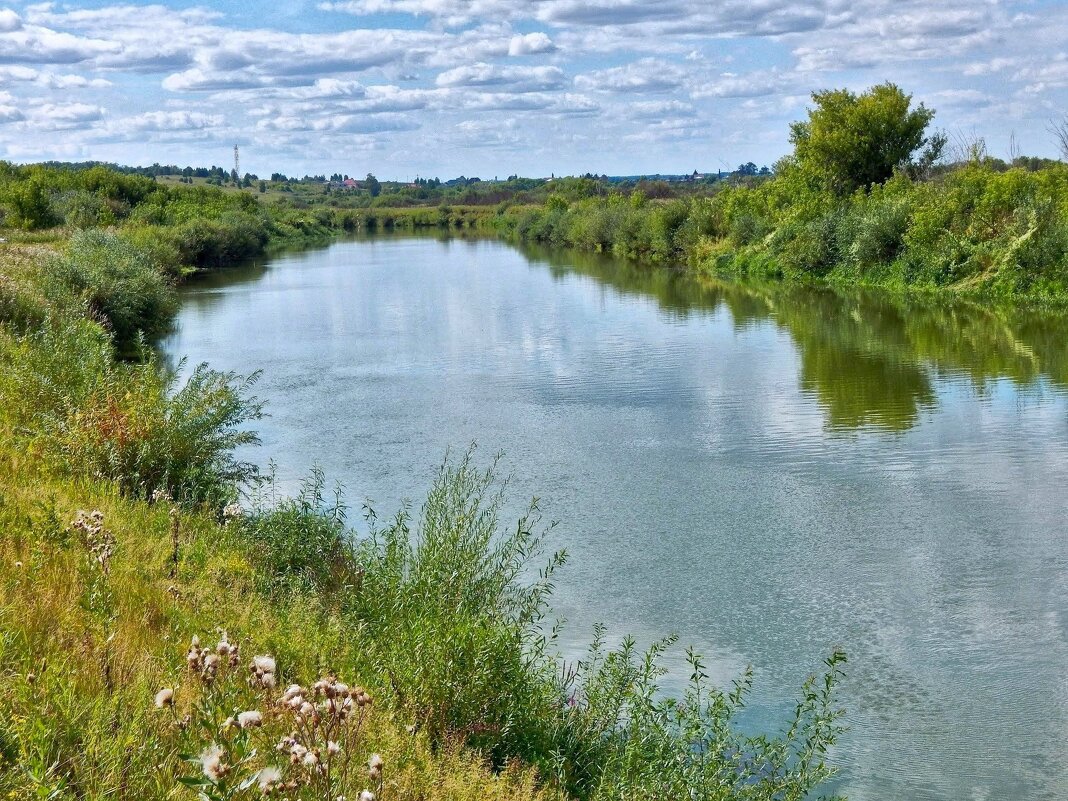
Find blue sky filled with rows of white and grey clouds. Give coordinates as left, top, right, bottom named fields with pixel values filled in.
left=0, top=0, right=1068, bottom=179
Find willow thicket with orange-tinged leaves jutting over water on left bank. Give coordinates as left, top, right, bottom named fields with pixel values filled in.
left=0, top=320, right=261, bottom=507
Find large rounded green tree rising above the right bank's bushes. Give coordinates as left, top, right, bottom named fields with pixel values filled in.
left=790, top=83, right=946, bottom=194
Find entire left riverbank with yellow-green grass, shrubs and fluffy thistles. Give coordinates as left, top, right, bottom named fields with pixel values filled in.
left=0, top=168, right=844, bottom=801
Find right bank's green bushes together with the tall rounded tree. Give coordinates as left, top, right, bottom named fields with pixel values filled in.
left=498, top=84, right=1068, bottom=301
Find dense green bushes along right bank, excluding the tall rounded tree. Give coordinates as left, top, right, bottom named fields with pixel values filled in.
left=498, top=162, right=1068, bottom=304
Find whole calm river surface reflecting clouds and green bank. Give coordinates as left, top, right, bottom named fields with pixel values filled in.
left=166, top=234, right=1068, bottom=801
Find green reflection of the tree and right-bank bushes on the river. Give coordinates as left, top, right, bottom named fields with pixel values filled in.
left=523, top=247, right=1068, bottom=431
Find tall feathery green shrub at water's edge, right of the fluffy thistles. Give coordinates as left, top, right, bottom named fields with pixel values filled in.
left=351, top=452, right=564, bottom=761
